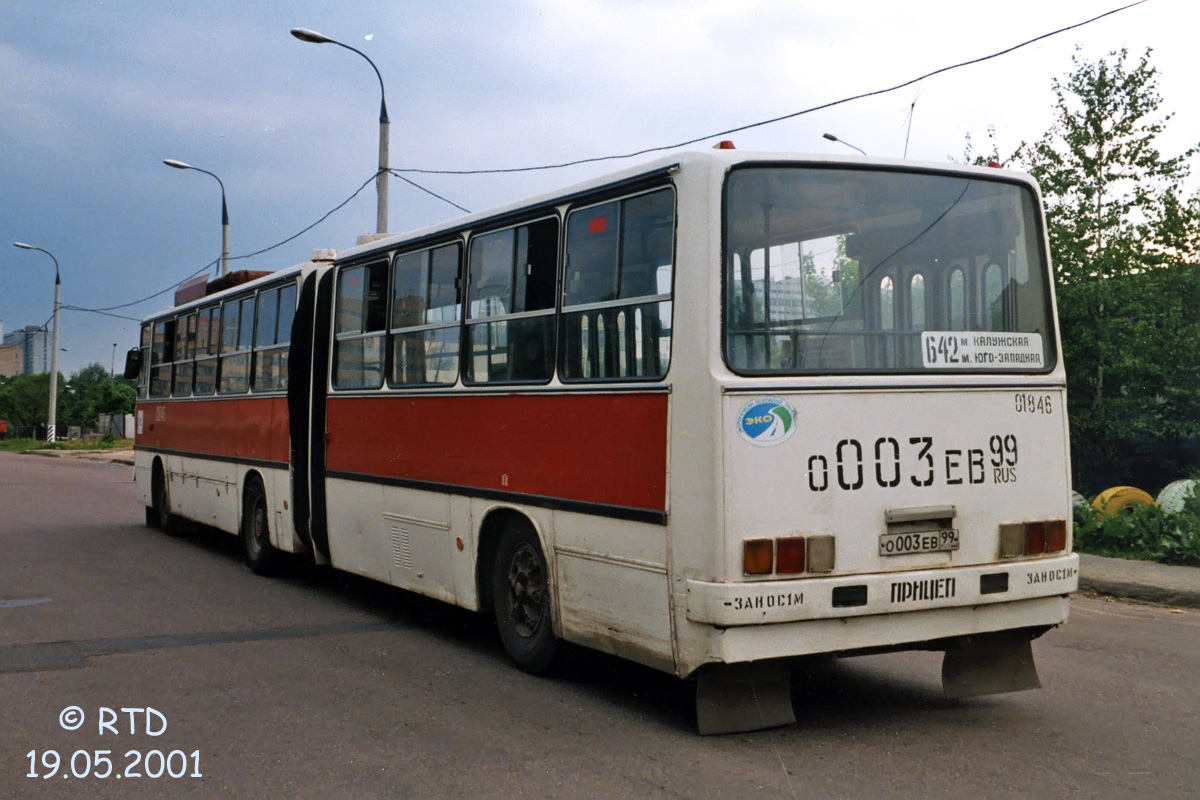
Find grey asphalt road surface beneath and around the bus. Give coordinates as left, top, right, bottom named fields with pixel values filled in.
left=0, top=453, right=1200, bottom=800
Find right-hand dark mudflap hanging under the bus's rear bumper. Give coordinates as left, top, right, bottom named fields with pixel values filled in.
left=942, top=631, right=1042, bottom=698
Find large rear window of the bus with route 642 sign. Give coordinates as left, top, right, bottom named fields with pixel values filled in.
left=724, top=167, right=1055, bottom=374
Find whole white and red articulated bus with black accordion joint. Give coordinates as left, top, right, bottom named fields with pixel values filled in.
left=130, top=150, right=1079, bottom=733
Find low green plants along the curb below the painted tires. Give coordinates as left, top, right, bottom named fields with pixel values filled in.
left=1075, top=495, right=1200, bottom=565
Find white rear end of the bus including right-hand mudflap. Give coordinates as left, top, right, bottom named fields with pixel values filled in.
left=686, top=161, right=1079, bottom=729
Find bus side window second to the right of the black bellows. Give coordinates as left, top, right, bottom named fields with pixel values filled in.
left=389, top=243, right=462, bottom=386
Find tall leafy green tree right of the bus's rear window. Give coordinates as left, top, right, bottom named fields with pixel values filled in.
left=1012, top=49, right=1200, bottom=489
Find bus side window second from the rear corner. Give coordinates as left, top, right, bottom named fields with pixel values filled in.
left=464, top=218, right=558, bottom=384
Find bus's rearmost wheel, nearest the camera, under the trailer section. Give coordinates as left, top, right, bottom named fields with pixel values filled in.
left=492, top=522, right=558, bottom=675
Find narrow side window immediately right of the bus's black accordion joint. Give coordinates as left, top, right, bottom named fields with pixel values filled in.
left=334, top=261, right=388, bottom=389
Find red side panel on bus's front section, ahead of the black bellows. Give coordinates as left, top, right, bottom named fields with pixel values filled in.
left=137, top=396, right=288, bottom=463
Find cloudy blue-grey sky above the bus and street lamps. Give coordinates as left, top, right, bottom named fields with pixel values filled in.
left=0, top=0, right=1200, bottom=375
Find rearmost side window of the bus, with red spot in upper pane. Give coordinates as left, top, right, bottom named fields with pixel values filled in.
left=559, top=190, right=674, bottom=381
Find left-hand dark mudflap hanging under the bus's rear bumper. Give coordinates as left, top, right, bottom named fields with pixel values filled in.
left=696, top=661, right=796, bottom=736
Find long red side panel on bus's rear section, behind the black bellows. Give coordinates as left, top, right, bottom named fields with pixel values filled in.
left=326, top=392, right=667, bottom=511
